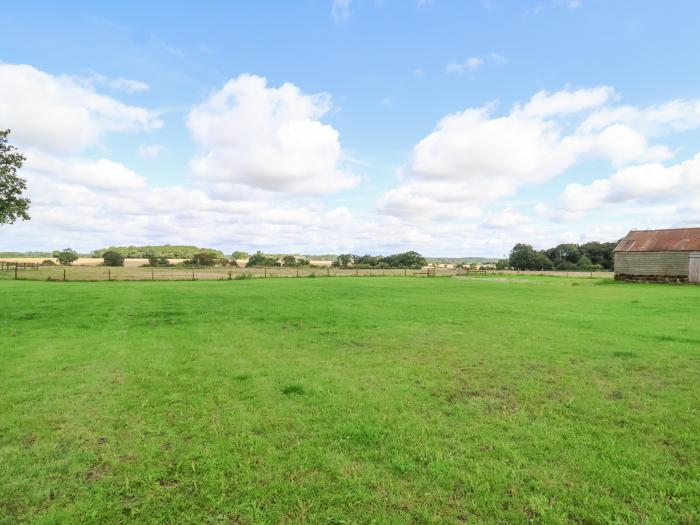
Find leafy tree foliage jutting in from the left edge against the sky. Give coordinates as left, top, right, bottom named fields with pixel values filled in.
left=0, top=129, right=31, bottom=224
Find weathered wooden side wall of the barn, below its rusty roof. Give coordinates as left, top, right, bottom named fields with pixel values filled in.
left=615, top=251, right=689, bottom=280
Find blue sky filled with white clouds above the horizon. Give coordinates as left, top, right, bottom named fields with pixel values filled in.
left=0, top=0, right=700, bottom=257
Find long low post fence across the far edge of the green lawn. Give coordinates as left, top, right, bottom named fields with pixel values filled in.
left=0, top=262, right=614, bottom=281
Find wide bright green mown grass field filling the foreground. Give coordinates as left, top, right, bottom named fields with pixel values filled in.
left=0, top=277, right=700, bottom=524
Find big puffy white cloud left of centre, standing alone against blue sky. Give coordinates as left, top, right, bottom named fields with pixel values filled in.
left=187, top=75, right=357, bottom=194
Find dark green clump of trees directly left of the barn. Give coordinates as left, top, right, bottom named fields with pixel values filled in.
left=496, top=242, right=618, bottom=272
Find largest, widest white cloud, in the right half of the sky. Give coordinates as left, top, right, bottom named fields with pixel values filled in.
left=378, top=86, right=700, bottom=217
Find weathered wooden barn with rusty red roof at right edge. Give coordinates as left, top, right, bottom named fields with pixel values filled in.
left=615, top=228, right=700, bottom=283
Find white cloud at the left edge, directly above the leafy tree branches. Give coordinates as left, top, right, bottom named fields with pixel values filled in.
left=0, top=64, right=162, bottom=154
